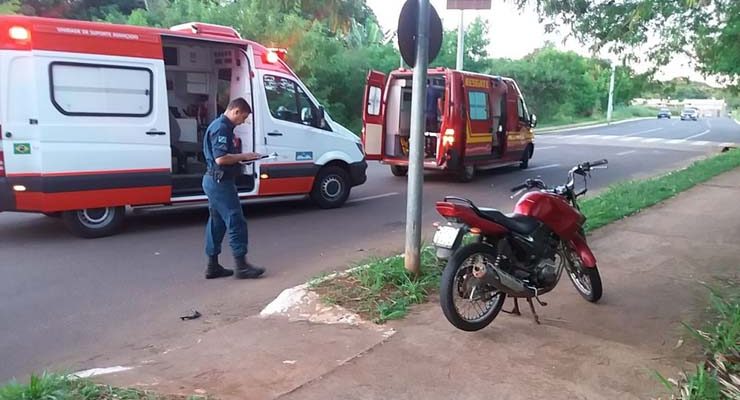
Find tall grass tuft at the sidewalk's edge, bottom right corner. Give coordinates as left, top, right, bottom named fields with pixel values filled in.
left=656, top=282, right=740, bottom=400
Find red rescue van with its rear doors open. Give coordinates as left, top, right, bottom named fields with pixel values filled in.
left=362, top=68, right=537, bottom=182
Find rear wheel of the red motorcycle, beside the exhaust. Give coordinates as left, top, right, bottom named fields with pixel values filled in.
left=439, top=243, right=506, bottom=332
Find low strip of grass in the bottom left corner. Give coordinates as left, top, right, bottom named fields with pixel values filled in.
left=0, top=373, right=207, bottom=400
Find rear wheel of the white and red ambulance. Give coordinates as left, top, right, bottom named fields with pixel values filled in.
left=62, top=207, right=126, bottom=239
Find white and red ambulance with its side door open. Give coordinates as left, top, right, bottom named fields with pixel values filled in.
left=0, top=16, right=367, bottom=237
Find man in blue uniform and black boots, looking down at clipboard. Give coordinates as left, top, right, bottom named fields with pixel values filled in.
left=203, top=97, right=265, bottom=279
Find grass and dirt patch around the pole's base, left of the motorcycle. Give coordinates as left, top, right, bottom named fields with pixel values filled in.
left=310, top=247, right=442, bottom=323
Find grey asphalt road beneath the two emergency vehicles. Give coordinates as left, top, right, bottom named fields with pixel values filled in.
left=0, top=118, right=740, bottom=382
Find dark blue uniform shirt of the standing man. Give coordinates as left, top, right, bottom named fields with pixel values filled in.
left=203, top=114, right=240, bottom=179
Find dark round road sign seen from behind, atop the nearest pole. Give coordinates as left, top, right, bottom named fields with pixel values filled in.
left=398, top=0, right=442, bottom=68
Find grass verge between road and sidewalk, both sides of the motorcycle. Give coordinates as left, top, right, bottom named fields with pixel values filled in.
left=309, top=150, right=740, bottom=323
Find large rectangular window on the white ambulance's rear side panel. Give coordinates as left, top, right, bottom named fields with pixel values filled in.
left=49, top=62, right=154, bottom=117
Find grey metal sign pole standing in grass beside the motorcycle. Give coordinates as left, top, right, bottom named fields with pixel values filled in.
left=404, top=0, right=430, bottom=275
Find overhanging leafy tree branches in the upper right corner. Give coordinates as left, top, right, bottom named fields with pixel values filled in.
left=516, top=0, right=740, bottom=83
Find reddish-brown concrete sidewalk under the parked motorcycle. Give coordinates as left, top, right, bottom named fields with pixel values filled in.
left=96, top=170, right=740, bottom=400
